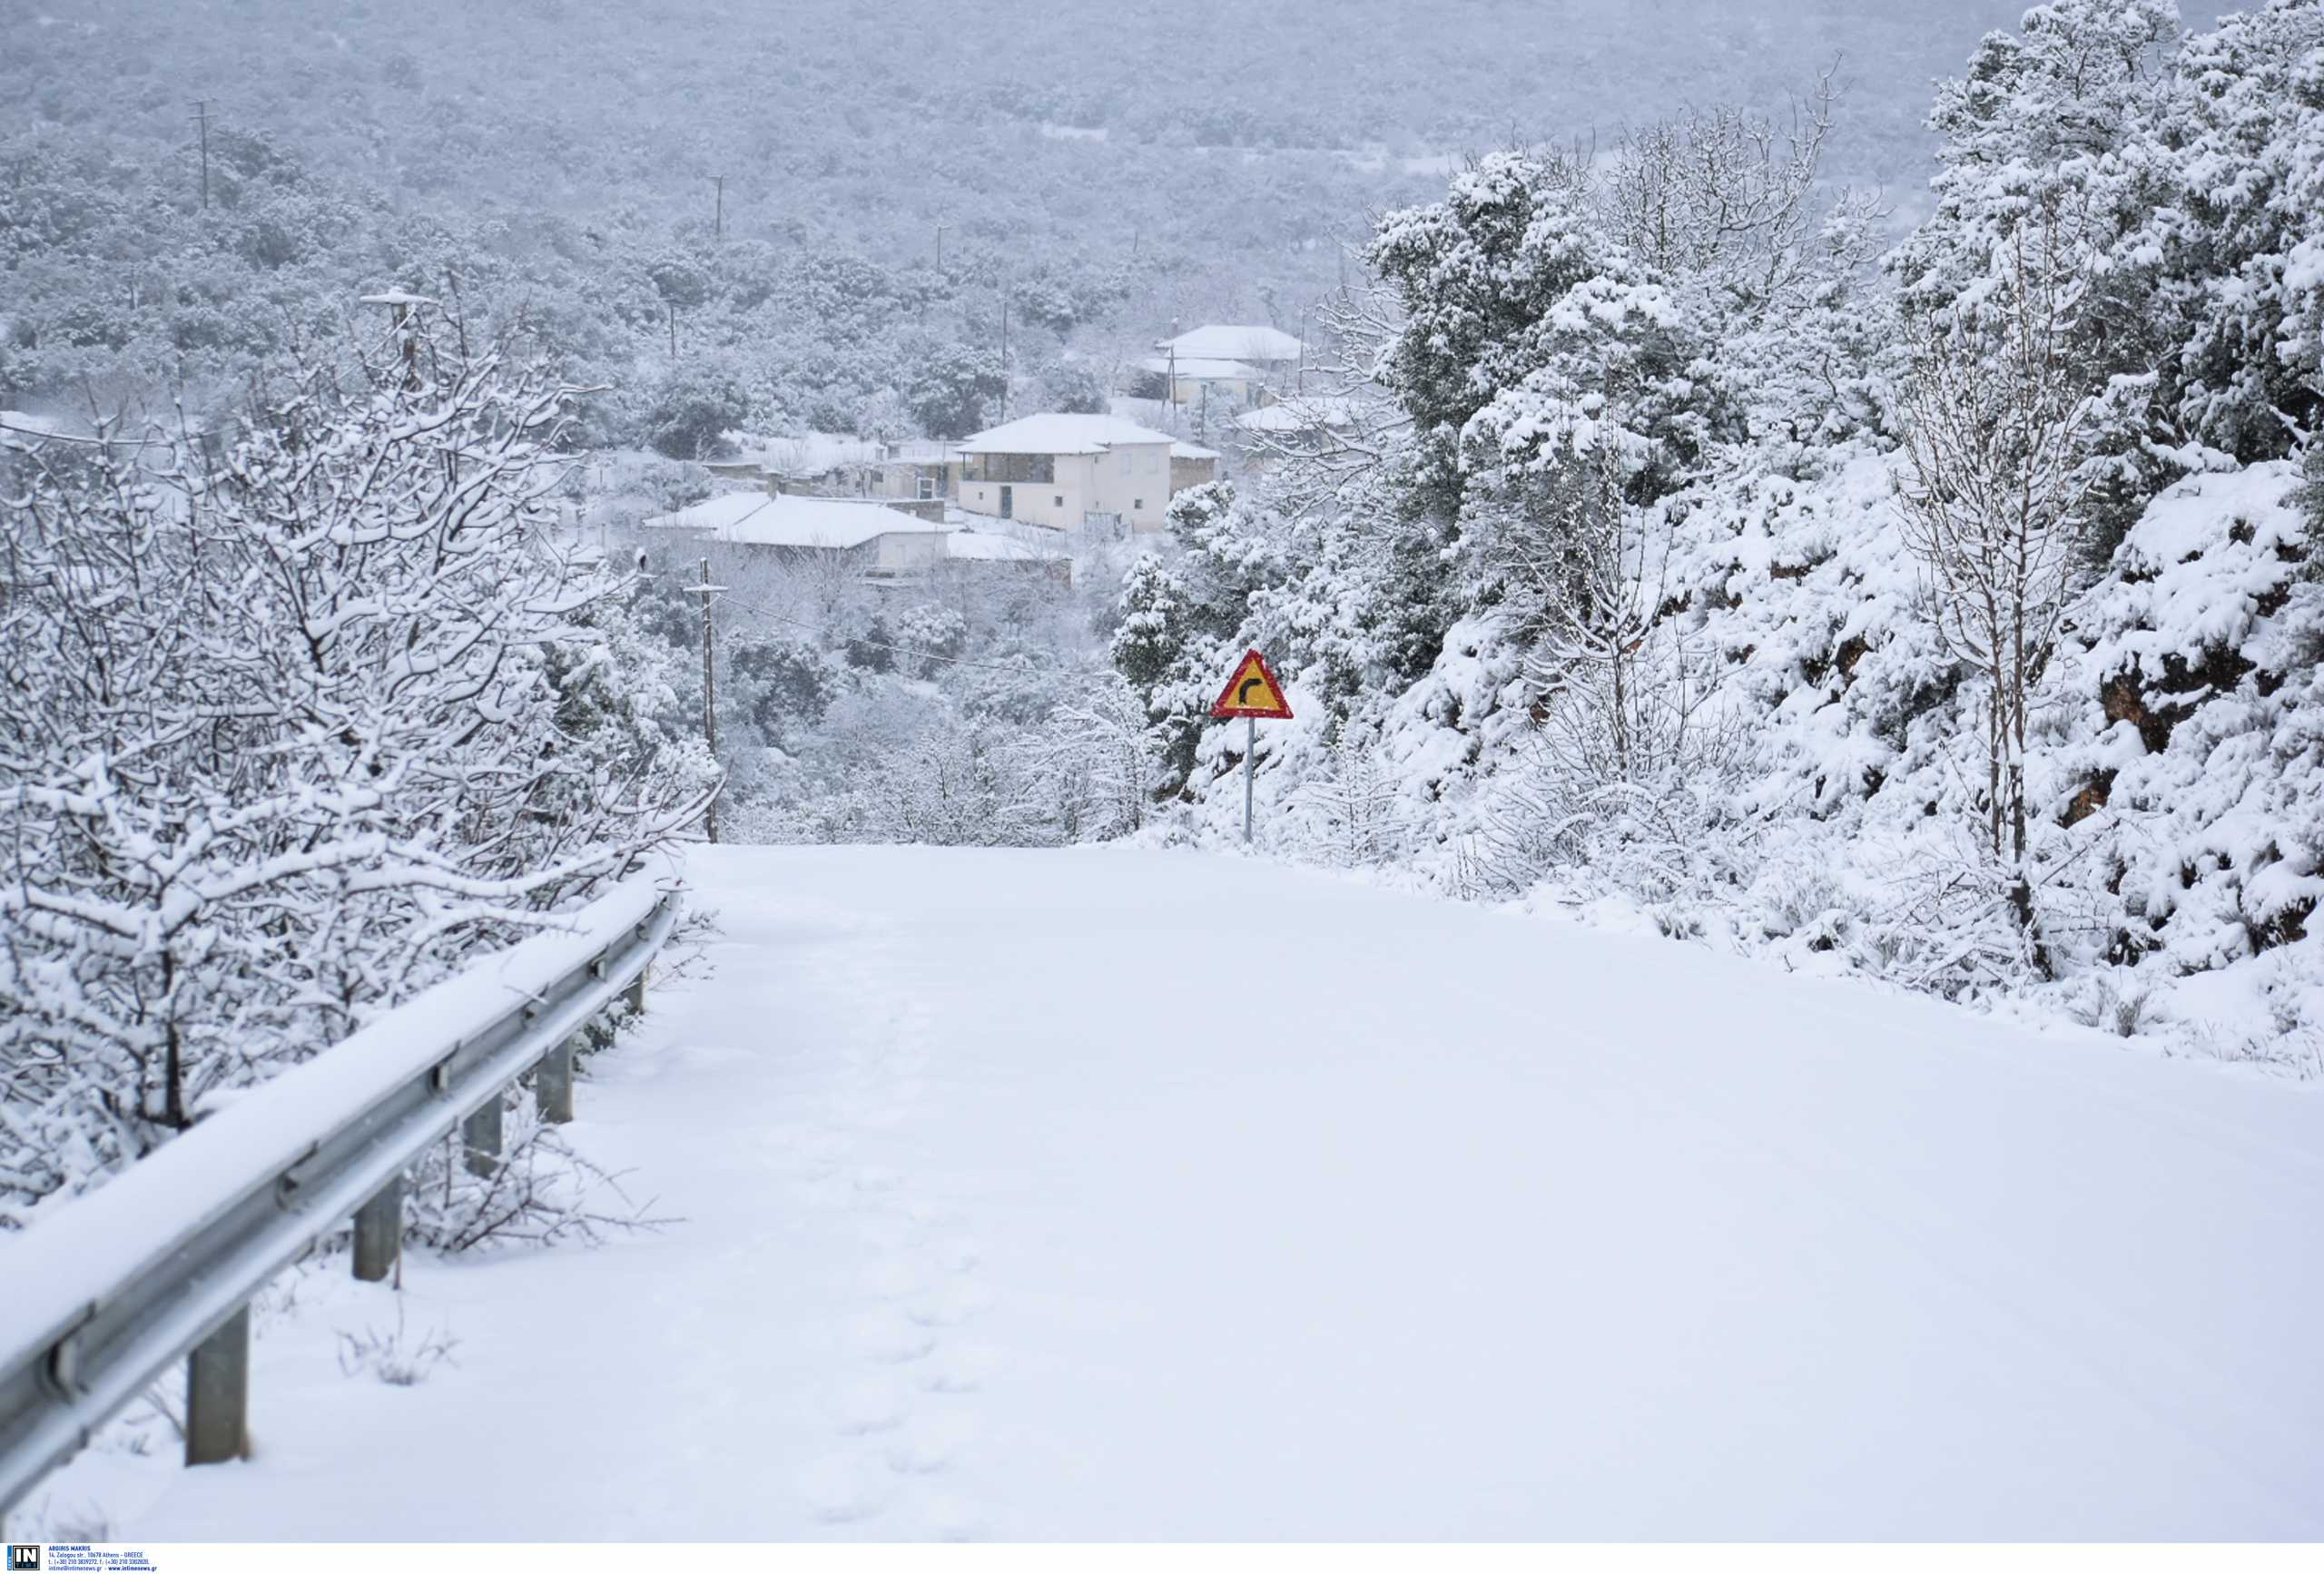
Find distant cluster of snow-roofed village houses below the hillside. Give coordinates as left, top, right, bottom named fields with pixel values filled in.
left=644, top=323, right=1348, bottom=581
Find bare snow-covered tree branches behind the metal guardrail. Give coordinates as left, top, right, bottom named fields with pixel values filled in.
left=0, top=326, right=714, bottom=1223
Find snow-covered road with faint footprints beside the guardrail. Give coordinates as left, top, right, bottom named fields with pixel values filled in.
left=67, top=849, right=2324, bottom=1541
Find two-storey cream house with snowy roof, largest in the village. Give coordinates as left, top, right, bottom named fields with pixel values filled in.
left=955, top=414, right=1174, bottom=530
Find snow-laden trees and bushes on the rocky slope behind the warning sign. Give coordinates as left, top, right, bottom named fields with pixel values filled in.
left=1116, top=12, right=2324, bottom=1072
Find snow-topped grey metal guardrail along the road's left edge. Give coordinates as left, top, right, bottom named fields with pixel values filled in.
left=0, top=881, right=679, bottom=1509
